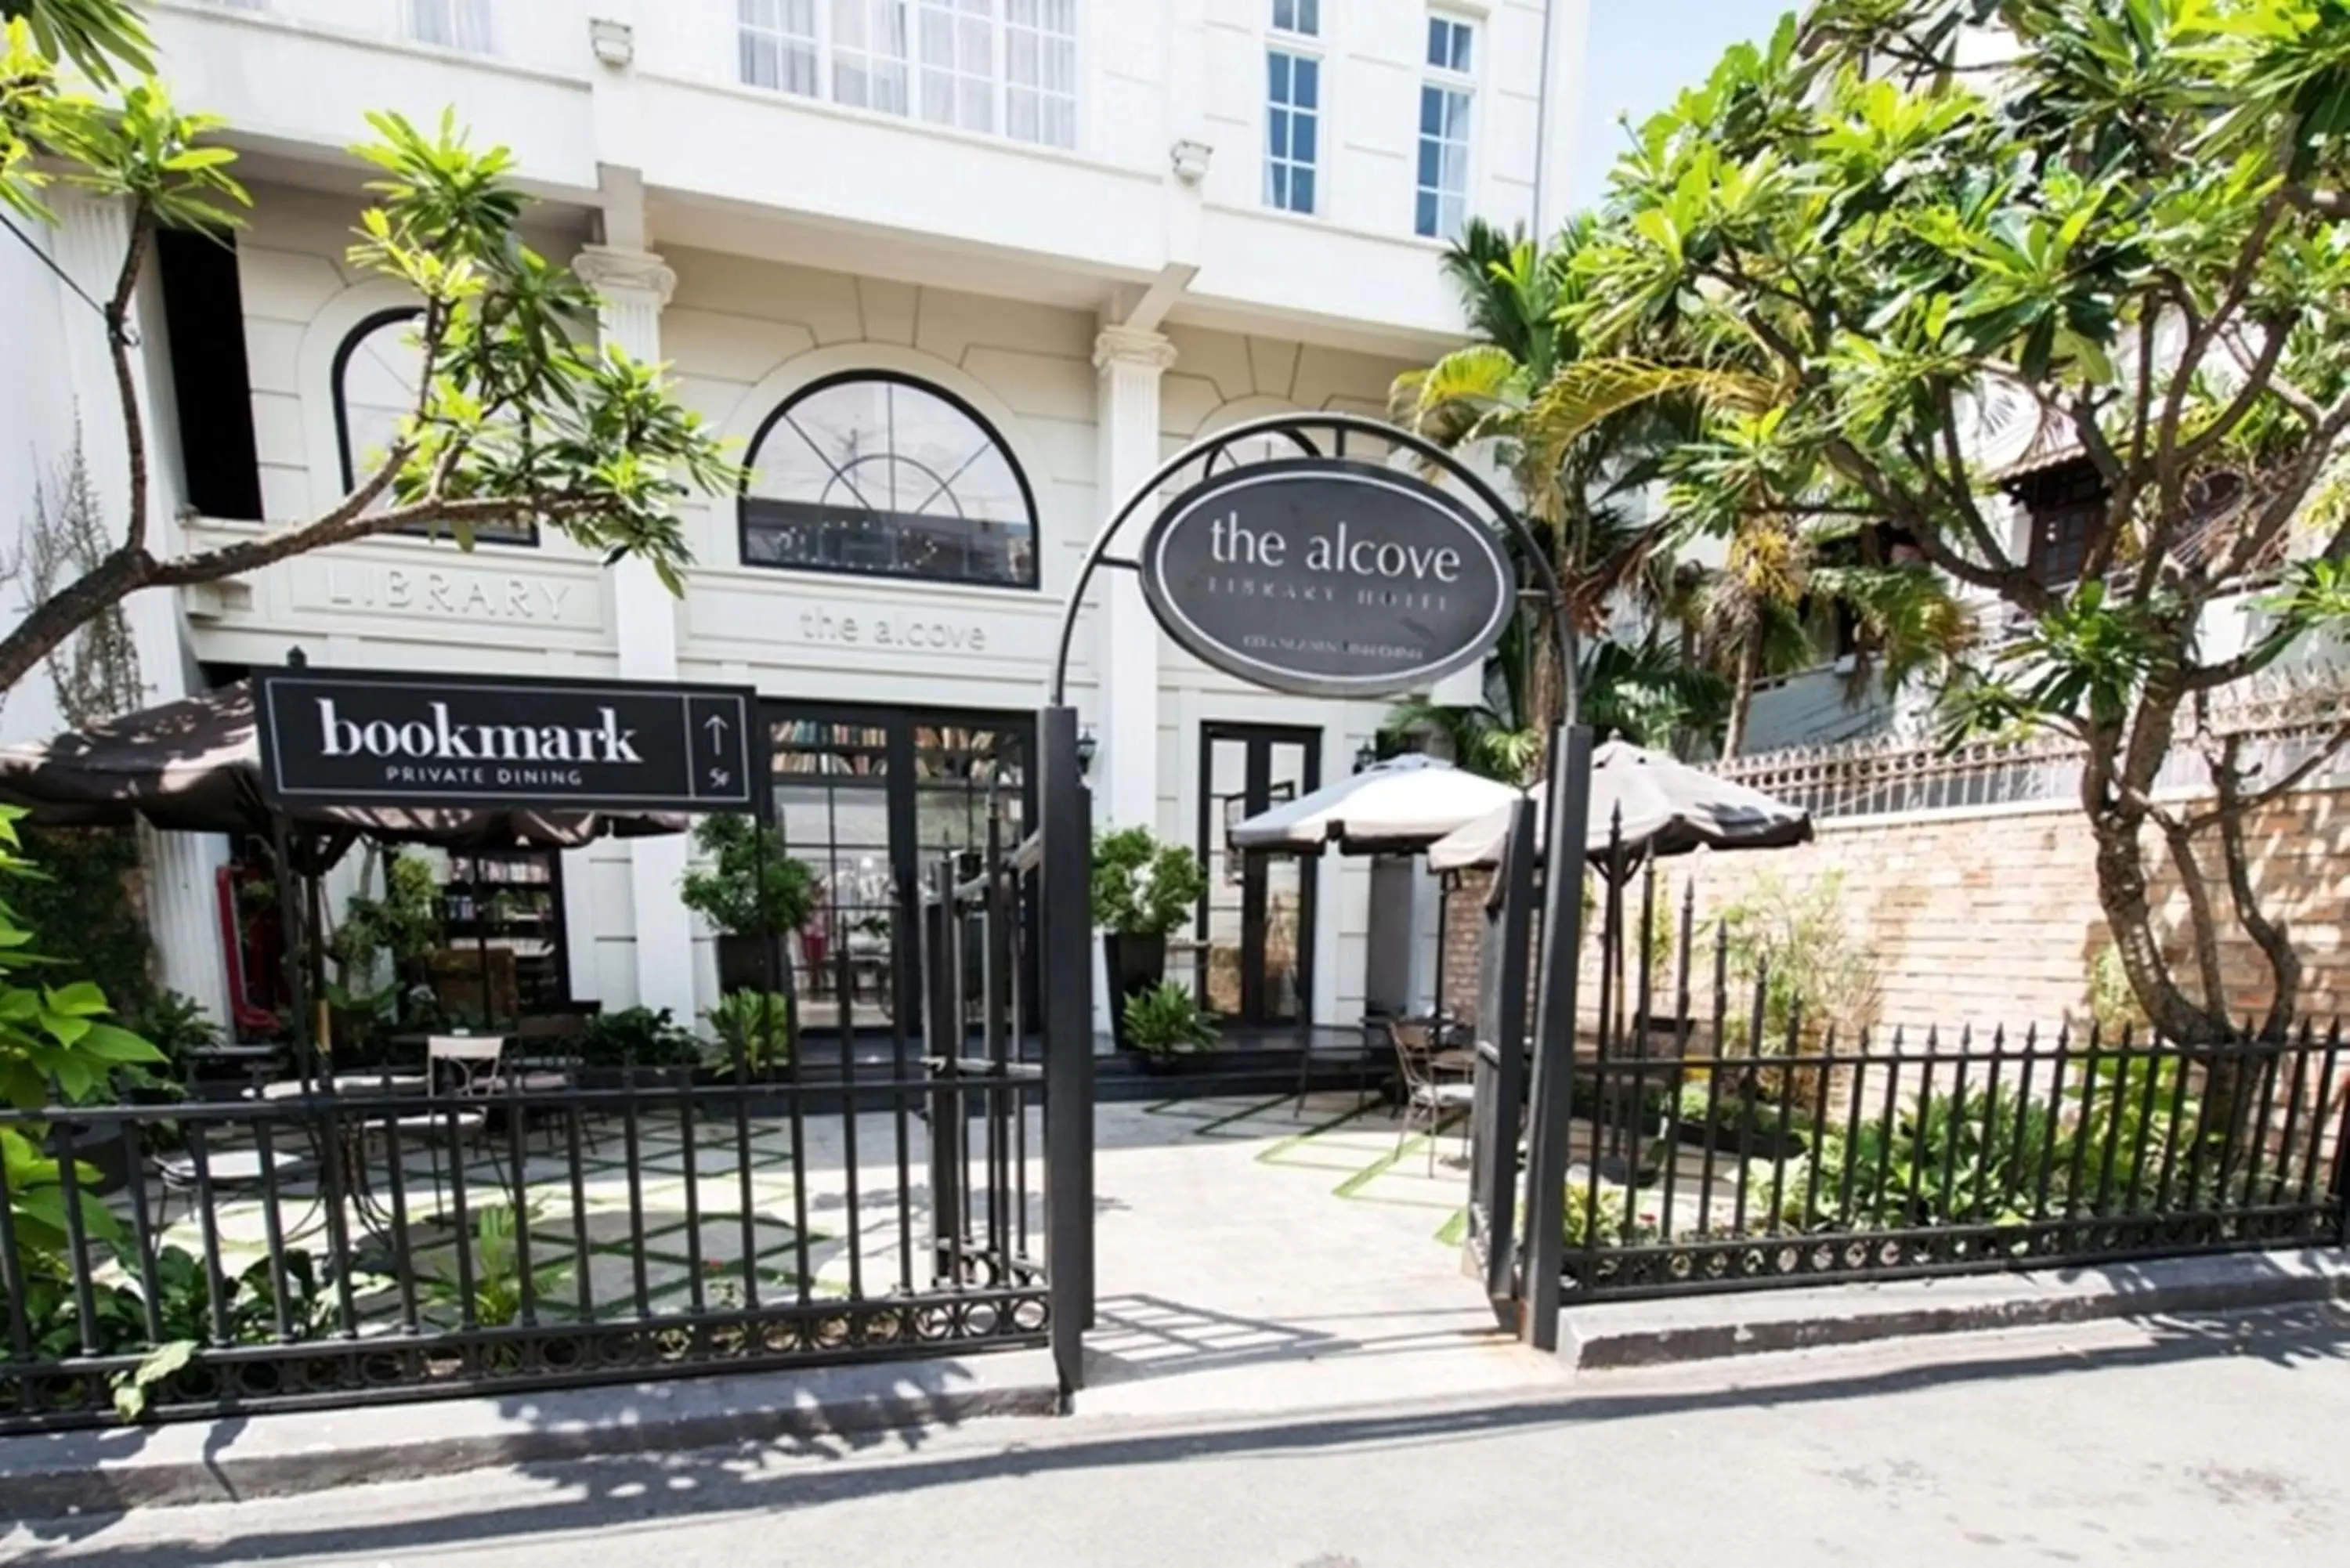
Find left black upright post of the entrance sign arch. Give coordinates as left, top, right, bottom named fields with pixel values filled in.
left=1036, top=705, right=1093, bottom=1406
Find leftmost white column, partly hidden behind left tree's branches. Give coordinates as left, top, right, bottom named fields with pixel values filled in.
left=54, top=190, right=228, bottom=1021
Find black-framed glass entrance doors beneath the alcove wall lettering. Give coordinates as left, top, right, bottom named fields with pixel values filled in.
left=766, top=703, right=1034, bottom=1042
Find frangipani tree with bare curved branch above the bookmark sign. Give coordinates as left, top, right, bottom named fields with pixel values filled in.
left=0, top=0, right=736, bottom=691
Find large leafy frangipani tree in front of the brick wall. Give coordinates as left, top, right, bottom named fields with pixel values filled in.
left=1577, top=0, right=2350, bottom=1042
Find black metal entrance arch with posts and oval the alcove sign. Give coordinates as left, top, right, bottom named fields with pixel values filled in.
left=1032, top=411, right=1591, bottom=1399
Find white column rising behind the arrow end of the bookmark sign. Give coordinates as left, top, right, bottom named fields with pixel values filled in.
left=571, top=244, right=693, bottom=1025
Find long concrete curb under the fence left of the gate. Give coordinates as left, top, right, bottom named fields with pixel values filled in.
left=0, top=1352, right=1060, bottom=1523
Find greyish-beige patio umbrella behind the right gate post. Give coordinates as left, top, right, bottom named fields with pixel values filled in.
left=1429, top=740, right=1812, bottom=873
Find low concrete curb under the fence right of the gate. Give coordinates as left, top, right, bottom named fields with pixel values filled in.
left=1558, top=1251, right=2350, bottom=1371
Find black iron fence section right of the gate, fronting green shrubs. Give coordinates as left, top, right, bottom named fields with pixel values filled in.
left=1560, top=856, right=2350, bottom=1295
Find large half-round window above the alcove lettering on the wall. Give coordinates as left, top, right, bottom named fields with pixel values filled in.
left=743, top=371, right=1036, bottom=587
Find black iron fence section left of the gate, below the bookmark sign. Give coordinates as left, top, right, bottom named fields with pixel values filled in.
left=0, top=982, right=1050, bottom=1432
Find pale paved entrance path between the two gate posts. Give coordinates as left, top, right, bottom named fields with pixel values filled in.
left=1079, top=1093, right=1563, bottom=1415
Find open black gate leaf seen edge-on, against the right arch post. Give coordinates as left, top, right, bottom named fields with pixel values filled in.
left=1469, top=797, right=1535, bottom=1302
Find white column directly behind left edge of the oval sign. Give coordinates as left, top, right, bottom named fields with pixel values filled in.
left=1093, top=327, right=1175, bottom=833
